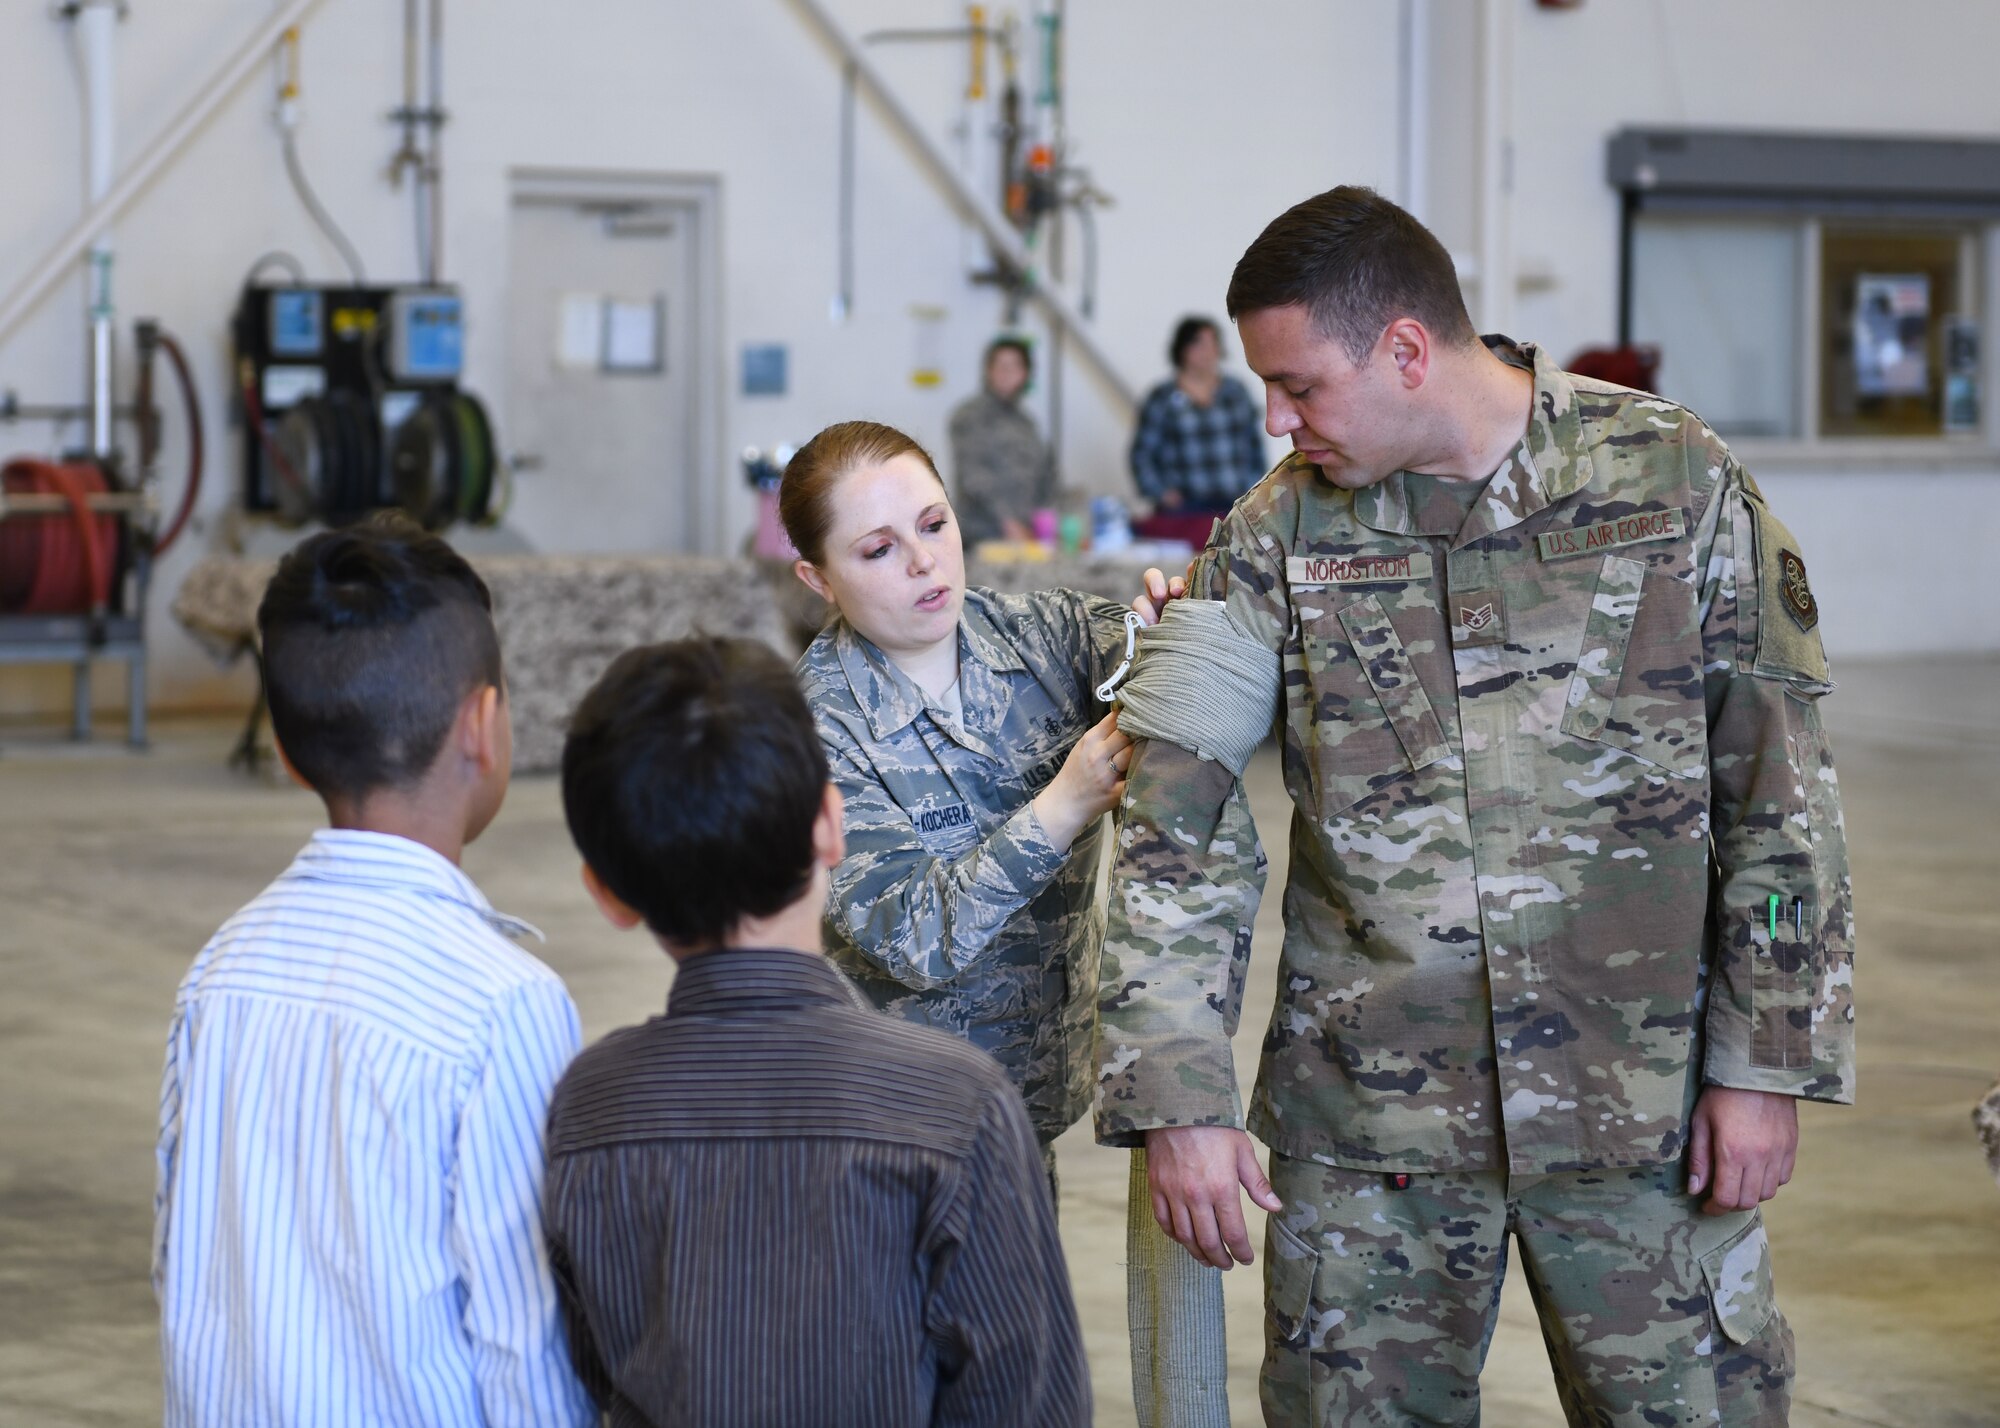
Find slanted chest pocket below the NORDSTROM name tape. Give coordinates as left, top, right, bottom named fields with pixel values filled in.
left=1286, top=590, right=1452, bottom=818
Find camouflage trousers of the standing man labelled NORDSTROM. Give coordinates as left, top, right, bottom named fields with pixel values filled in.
left=1262, top=1154, right=1792, bottom=1428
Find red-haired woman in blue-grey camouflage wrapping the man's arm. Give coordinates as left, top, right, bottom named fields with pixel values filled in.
left=780, top=422, right=1130, bottom=1166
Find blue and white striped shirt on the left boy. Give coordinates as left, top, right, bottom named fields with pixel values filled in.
left=154, top=830, right=596, bottom=1428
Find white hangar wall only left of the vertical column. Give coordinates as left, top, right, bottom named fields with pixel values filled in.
left=0, top=0, right=1396, bottom=712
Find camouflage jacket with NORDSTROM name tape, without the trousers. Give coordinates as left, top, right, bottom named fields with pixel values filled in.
left=1098, top=344, right=1854, bottom=1174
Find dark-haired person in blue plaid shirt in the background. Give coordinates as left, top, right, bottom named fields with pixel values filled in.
left=1132, top=318, right=1266, bottom=520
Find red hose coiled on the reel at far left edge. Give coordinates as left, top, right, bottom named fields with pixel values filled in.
left=0, top=458, right=118, bottom=614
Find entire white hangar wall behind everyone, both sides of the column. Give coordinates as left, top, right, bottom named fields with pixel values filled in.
left=0, top=0, right=2000, bottom=714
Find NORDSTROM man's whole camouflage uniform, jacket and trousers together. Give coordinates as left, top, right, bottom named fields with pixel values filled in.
left=1098, top=340, right=1854, bottom=1426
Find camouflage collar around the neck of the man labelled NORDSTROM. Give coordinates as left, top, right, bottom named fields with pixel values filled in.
left=1354, top=336, right=1594, bottom=546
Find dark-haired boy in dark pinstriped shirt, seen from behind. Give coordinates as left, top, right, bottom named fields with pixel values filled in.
left=548, top=638, right=1090, bottom=1428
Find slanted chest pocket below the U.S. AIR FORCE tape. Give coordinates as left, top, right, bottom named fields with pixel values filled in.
left=1562, top=556, right=1708, bottom=778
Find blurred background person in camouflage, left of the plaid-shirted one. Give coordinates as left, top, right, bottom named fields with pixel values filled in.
left=950, top=336, right=1056, bottom=544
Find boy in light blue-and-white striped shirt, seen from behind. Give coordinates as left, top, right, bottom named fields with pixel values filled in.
left=152, top=520, right=596, bottom=1428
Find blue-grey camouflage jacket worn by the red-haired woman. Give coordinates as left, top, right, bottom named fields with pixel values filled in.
left=798, top=588, right=1124, bottom=1140
